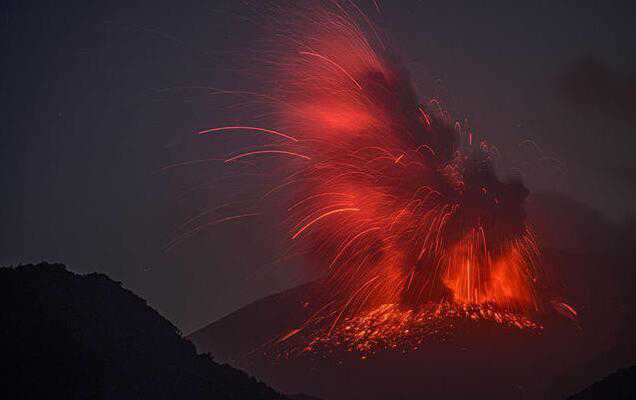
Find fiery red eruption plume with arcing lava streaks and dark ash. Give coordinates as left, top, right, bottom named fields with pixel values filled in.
left=183, top=1, right=572, bottom=352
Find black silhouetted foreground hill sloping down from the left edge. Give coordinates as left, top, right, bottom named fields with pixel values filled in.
left=0, top=264, right=284, bottom=400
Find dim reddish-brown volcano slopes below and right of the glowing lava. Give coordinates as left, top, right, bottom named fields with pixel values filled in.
left=189, top=196, right=636, bottom=400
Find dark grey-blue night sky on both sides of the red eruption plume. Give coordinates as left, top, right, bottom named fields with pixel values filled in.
left=0, top=0, right=636, bottom=332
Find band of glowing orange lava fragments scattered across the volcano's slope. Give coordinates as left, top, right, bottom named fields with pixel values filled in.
left=272, top=301, right=543, bottom=359
